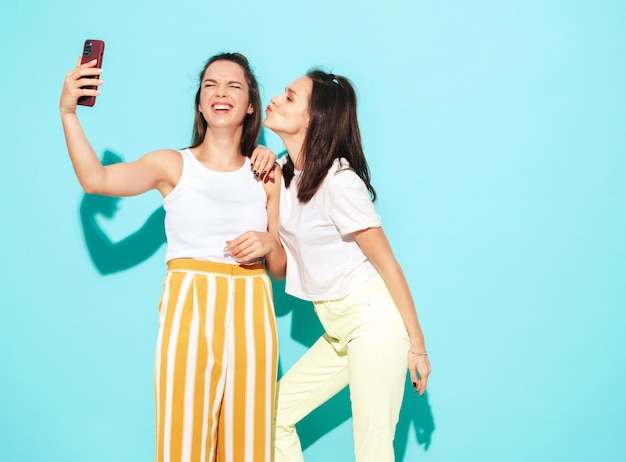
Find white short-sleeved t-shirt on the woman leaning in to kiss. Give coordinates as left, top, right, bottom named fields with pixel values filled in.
left=278, top=159, right=381, bottom=301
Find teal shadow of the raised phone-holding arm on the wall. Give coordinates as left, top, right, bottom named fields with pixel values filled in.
left=80, top=151, right=165, bottom=274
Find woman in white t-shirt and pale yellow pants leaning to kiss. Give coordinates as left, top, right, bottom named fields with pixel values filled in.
left=264, top=71, right=431, bottom=462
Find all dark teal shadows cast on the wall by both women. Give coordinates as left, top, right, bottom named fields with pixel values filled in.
left=80, top=151, right=435, bottom=454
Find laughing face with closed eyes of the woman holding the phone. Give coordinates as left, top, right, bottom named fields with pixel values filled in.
left=198, top=60, right=254, bottom=128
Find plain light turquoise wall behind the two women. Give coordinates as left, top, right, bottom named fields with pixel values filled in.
left=0, top=0, right=626, bottom=462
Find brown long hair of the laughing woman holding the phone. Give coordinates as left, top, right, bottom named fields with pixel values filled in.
left=190, top=53, right=261, bottom=157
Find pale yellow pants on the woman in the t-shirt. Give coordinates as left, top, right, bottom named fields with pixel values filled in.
left=274, top=275, right=409, bottom=462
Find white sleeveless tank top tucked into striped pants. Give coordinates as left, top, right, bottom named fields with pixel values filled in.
left=163, top=149, right=267, bottom=264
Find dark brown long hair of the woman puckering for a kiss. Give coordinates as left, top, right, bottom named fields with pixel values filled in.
left=283, top=69, right=376, bottom=203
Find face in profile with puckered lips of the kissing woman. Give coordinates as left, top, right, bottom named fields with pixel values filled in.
left=263, top=76, right=313, bottom=142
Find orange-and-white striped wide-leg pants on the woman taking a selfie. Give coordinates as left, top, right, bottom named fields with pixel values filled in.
left=154, top=259, right=278, bottom=462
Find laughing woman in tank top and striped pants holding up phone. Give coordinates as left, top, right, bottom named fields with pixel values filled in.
left=60, top=53, right=286, bottom=462
